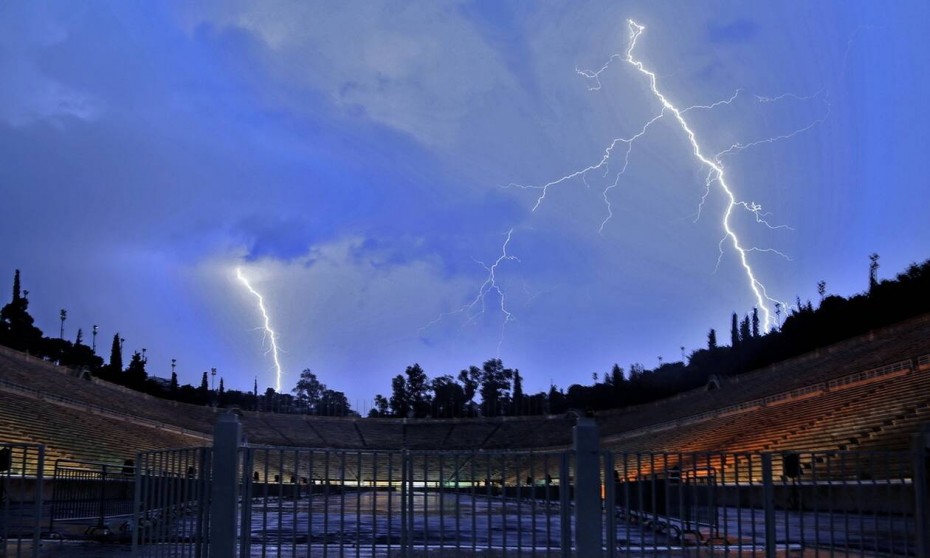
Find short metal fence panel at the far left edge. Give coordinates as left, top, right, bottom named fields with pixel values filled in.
left=0, top=442, right=45, bottom=558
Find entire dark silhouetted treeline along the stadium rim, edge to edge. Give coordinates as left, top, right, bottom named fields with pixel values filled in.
left=0, top=254, right=930, bottom=418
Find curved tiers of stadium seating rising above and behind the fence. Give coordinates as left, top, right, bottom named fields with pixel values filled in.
left=0, top=316, right=930, bottom=472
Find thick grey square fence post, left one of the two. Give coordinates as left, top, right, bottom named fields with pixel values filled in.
left=208, top=414, right=241, bottom=558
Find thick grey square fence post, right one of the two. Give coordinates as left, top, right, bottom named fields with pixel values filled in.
left=572, top=417, right=602, bottom=556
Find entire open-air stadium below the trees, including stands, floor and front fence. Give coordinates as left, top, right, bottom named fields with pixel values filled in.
left=0, top=315, right=930, bottom=557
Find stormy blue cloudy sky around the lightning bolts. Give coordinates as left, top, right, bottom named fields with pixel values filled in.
left=0, top=1, right=930, bottom=411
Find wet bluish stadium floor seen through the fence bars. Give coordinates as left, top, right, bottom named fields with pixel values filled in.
left=0, top=491, right=915, bottom=558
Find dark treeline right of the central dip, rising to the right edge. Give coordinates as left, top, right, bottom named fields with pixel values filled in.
left=369, top=254, right=930, bottom=418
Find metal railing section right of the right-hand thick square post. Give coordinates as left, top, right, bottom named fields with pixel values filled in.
left=605, top=451, right=927, bottom=556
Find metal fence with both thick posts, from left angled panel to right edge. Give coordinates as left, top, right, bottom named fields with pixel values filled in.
left=133, top=418, right=930, bottom=558
